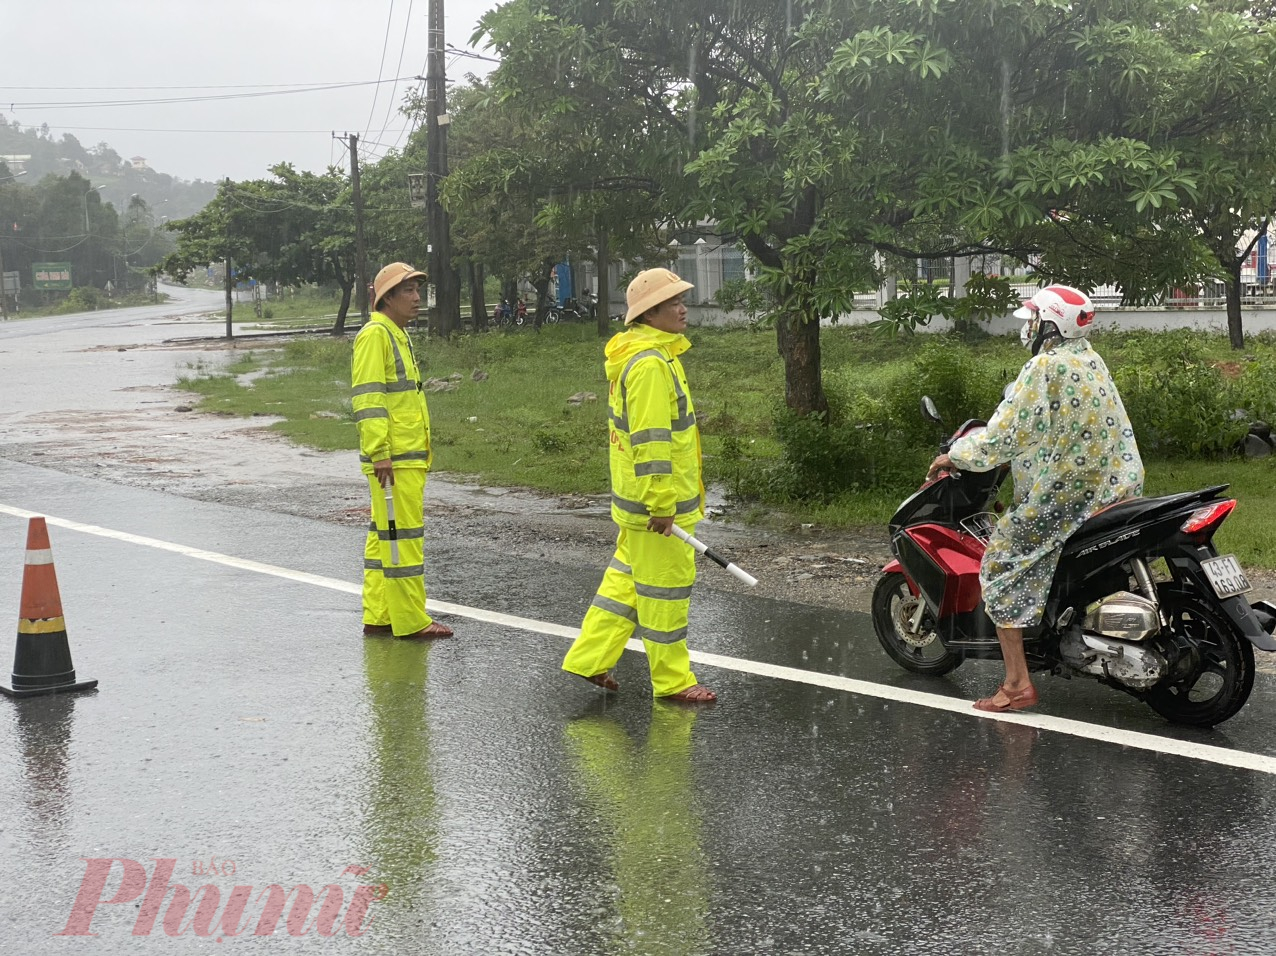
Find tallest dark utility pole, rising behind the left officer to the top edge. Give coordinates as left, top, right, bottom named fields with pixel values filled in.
left=425, top=0, right=461, bottom=336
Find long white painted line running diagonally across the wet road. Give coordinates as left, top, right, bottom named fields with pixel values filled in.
left=7, top=504, right=1276, bottom=775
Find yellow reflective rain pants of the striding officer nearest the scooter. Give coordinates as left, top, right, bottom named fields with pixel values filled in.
left=563, top=525, right=697, bottom=697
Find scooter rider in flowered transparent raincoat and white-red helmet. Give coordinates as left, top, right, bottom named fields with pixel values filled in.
left=926, top=285, right=1143, bottom=712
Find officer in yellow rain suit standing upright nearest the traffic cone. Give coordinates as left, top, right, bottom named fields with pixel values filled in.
left=350, top=262, right=452, bottom=638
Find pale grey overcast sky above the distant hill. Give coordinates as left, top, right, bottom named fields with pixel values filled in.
left=0, top=0, right=499, bottom=180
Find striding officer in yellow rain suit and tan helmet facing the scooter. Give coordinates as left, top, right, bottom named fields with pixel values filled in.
left=563, top=269, right=717, bottom=703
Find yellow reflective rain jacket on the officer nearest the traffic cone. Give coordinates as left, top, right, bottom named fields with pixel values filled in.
left=350, top=311, right=430, bottom=475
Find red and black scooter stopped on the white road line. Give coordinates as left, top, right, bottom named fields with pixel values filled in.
left=873, top=397, right=1276, bottom=726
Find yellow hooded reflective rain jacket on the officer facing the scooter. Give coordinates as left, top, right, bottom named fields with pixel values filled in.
left=606, top=325, right=704, bottom=528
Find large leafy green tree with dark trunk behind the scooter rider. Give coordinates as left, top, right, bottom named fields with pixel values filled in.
left=481, top=0, right=1276, bottom=412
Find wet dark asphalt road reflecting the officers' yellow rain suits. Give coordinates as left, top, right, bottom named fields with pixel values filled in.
left=0, top=296, right=1276, bottom=956
